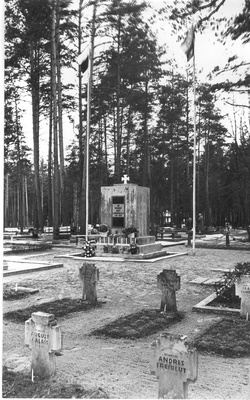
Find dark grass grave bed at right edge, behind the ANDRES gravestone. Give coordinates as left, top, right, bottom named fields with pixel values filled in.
left=193, top=317, right=250, bottom=358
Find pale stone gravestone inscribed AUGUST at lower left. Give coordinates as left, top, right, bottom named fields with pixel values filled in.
left=25, top=311, right=62, bottom=378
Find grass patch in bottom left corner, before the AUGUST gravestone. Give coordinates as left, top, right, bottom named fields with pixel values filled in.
left=2, top=367, right=109, bottom=399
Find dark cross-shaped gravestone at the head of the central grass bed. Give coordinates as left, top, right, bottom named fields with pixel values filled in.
left=157, top=269, right=181, bottom=311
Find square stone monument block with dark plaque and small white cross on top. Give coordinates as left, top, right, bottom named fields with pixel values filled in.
left=100, top=175, right=150, bottom=236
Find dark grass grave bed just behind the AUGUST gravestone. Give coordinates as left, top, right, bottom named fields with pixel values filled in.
left=3, top=298, right=102, bottom=323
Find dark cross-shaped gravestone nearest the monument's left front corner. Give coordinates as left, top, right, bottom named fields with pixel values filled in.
left=79, top=263, right=99, bottom=304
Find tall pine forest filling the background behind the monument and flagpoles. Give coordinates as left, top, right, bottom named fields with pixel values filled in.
left=4, top=0, right=250, bottom=235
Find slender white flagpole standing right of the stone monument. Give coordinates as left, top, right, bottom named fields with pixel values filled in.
left=193, top=51, right=196, bottom=255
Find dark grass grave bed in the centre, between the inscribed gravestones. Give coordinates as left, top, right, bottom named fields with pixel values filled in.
left=90, top=309, right=184, bottom=339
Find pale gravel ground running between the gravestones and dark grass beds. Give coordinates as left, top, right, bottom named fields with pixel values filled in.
left=3, top=242, right=250, bottom=400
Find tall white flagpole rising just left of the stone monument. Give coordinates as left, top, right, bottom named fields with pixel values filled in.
left=85, top=1, right=97, bottom=241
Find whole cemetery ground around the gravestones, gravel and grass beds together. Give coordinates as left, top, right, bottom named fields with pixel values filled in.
left=2, top=245, right=250, bottom=399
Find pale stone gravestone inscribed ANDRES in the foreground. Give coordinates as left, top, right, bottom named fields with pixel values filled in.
left=151, top=333, right=198, bottom=399
